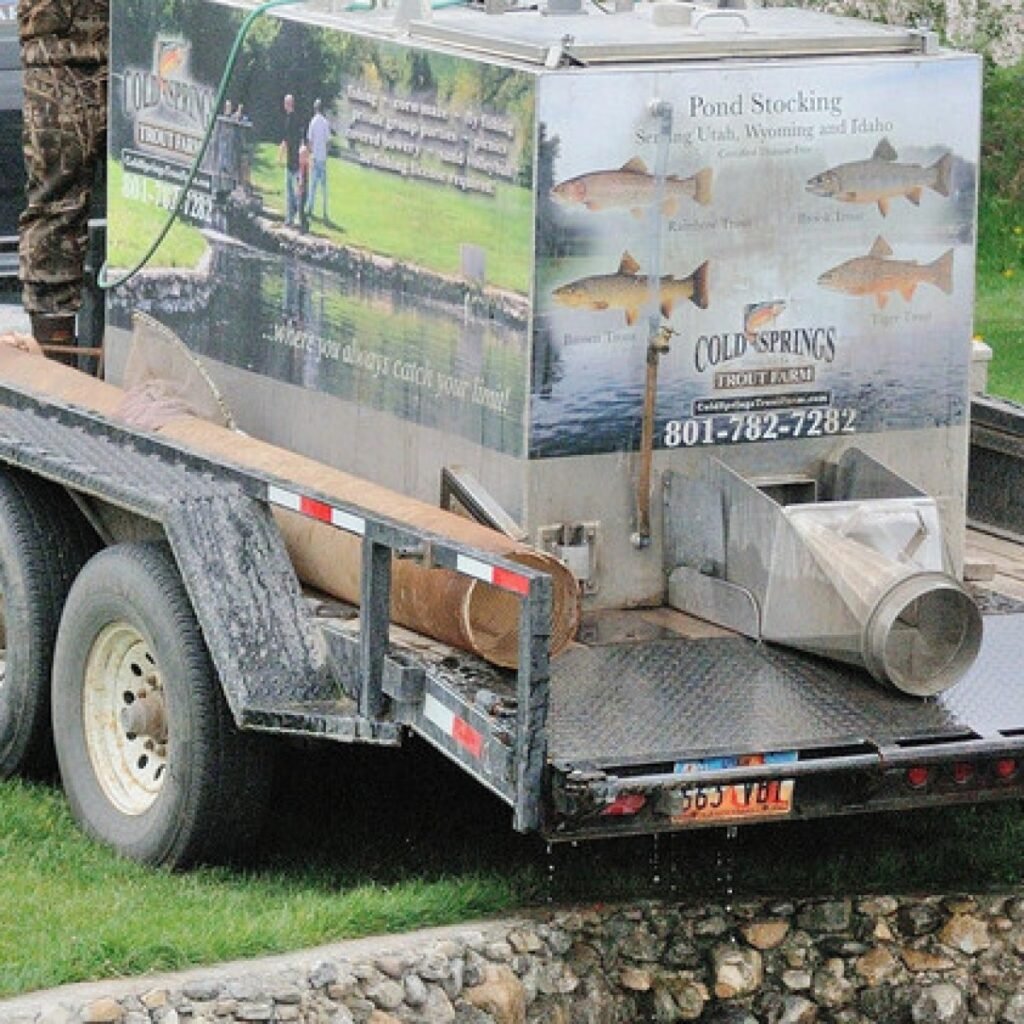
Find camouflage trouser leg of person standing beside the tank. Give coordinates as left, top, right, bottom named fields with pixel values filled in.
left=18, top=0, right=109, bottom=313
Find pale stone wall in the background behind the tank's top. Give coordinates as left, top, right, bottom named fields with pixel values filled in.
left=765, top=0, right=1024, bottom=65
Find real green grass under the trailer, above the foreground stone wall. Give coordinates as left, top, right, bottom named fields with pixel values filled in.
left=6, top=742, right=1024, bottom=997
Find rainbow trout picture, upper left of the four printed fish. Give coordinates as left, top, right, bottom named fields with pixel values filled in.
left=551, top=157, right=713, bottom=217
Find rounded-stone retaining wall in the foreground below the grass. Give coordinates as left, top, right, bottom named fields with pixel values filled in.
left=6, top=894, right=1024, bottom=1024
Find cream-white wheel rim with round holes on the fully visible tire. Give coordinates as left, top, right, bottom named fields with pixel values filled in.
left=82, top=623, right=167, bottom=815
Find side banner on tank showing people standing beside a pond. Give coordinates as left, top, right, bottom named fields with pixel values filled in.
left=109, top=0, right=535, bottom=455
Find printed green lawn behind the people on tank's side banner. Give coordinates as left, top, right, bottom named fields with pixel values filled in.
left=252, top=145, right=534, bottom=294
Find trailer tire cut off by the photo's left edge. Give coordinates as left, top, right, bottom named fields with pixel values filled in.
left=0, top=469, right=99, bottom=778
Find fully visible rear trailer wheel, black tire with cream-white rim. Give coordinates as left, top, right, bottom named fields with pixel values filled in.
left=53, top=543, right=269, bottom=868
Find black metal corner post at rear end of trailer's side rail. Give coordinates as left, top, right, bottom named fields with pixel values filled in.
left=512, top=575, right=552, bottom=831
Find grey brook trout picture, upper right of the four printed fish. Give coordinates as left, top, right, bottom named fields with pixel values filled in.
left=807, top=138, right=953, bottom=217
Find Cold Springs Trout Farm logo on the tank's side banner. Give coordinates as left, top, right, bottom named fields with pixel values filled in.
left=123, top=37, right=215, bottom=160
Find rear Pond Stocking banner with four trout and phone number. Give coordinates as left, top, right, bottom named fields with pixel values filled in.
left=529, top=58, right=980, bottom=458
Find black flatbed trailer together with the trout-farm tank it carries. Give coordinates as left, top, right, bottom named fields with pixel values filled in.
left=0, top=0, right=1024, bottom=865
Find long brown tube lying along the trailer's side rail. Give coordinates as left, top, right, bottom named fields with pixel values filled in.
left=0, top=346, right=580, bottom=668
